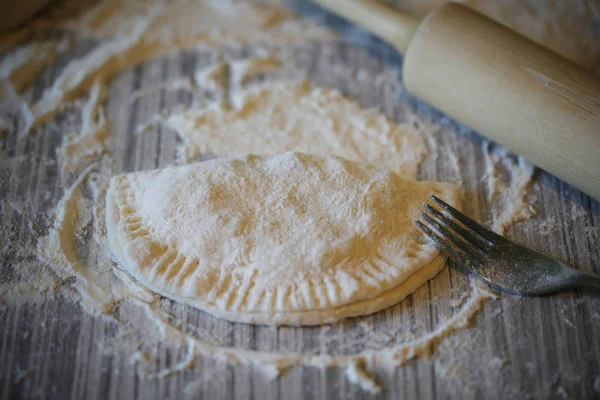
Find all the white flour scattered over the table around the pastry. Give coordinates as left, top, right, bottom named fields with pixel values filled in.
left=0, top=0, right=578, bottom=393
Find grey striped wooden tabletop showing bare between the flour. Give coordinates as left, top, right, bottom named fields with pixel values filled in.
left=0, top=0, right=600, bottom=399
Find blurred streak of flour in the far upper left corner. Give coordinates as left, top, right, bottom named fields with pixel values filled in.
left=2, top=0, right=332, bottom=131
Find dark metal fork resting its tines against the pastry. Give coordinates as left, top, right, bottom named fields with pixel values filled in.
left=415, top=194, right=600, bottom=295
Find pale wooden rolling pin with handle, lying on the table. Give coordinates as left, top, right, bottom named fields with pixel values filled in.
left=315, top=0, right=600, bottom=200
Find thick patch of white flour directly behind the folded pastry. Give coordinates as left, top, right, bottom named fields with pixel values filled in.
left=165, top=81, right=427, bottom=179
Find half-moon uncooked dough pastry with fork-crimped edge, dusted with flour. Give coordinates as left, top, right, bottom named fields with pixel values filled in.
left=107, top=152, right=456, bottom=325
